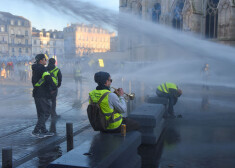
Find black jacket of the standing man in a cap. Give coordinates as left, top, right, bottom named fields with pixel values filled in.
left=32, top=64, right=57, bottom=98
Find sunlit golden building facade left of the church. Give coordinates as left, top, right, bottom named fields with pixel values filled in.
left=64, top=24, right=115, bottom=57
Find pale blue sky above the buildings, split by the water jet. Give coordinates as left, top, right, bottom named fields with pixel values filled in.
left=0, top=0, right=119, bottom=30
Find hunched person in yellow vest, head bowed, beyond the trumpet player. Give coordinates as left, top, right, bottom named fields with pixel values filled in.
left=156, top=82, right=182, bottom=118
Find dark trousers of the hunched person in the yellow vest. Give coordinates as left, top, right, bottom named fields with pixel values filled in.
left=156, top=90, right=178, bottom=115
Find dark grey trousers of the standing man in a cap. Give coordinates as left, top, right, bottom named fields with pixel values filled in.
left=34, top=97, right=51, bottom=132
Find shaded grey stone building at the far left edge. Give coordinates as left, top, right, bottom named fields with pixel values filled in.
left=0, top=12, right=32, bottom=57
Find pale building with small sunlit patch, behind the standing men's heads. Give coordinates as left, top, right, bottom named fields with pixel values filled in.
left=32, top=28, right=64, bottom=58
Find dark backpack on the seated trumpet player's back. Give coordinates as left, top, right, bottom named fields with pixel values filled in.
left=87, top=92, right=109, bottom=131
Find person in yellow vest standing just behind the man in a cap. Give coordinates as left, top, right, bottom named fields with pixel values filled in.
left=47, top=58, right=62, bottom=119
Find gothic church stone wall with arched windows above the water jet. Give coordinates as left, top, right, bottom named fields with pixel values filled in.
left=120, top=0, right=235, bottom=46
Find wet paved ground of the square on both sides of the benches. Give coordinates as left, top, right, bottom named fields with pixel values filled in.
left=0, top=80, right=235, bottom=168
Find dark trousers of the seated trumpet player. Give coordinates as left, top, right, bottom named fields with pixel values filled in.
left=103, top=117, right=140, bottom=133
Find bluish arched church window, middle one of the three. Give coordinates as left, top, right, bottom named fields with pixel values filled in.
left=172, top=0, right=185, bottom=30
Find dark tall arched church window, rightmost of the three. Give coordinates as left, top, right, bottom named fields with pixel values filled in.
left=205, top=0, right=219, bottom=38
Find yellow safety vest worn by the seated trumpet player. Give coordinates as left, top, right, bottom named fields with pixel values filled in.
left=89, top=90, right=122, bottom=130
